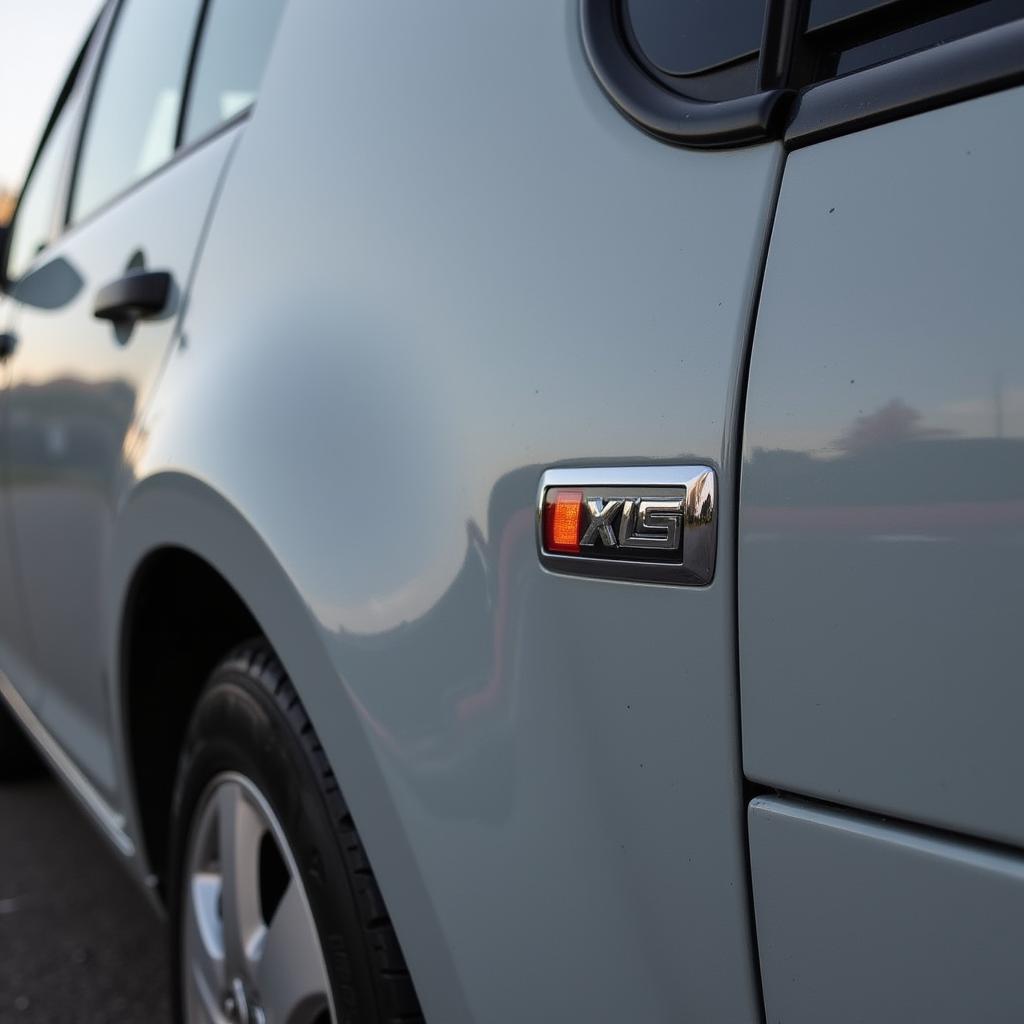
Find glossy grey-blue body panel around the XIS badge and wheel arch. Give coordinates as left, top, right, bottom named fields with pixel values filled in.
left=2, top=0, right=781, bottom=1024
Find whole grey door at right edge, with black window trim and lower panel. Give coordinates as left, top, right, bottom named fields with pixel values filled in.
left=738, top=3, right=1024, bottom=1024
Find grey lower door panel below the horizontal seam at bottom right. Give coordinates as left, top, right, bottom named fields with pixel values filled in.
left=750, top=799, right=1024, bottom=1024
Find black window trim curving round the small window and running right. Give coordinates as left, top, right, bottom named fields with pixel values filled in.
left=580, top=0, right=1024, bottom=150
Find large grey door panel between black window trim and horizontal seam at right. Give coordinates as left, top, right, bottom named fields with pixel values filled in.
left=739, top=89, right=1024, bottom=843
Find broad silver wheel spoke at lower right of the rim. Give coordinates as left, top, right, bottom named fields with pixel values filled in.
left=255, top=879, right=329, bottom=1024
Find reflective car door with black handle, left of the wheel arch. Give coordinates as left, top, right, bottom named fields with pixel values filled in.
left=6, top=0, right=280, bottom=799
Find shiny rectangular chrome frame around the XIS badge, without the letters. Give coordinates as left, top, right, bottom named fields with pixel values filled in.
left=536, top=466, right=718, bottom=587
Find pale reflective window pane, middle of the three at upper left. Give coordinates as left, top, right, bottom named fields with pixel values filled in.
left=72, top=0, right=200, bottom=220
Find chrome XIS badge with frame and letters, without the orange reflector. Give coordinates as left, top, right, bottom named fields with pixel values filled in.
left=537, top=466, right=718, bottom=587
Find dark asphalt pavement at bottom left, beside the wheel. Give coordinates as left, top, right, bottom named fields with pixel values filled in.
left=0, top=774, right=170, bottom=1024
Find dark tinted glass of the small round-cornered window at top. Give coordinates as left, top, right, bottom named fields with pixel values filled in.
left=626, top=0, right=765, bottom=75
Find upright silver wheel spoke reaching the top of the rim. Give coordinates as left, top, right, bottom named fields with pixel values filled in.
left=217, top=782, right=266, bottom=978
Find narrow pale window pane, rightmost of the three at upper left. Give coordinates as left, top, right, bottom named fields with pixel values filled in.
left=184, top=0, right=284, bottom=142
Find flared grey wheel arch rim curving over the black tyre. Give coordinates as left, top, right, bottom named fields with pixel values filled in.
left=108, top=471, right=462, bottom=1024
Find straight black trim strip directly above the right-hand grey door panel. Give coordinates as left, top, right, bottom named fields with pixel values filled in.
left=785, top=20, right=1024, bottom=148
